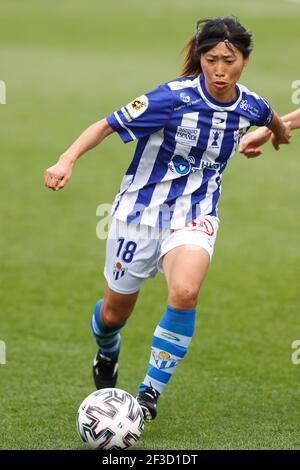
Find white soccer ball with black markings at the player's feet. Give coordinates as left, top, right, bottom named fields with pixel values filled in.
left=76, top=388, right=144, bottom=450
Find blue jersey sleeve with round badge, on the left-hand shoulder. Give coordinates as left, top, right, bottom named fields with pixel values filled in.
left=106, top=84, right=173, bottom=143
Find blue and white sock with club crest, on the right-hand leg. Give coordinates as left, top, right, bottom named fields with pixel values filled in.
left=139, top=306, right=196, bottom=394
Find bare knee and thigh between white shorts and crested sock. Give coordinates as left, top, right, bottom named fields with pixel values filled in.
left=163, top=245, right=210, bottom=309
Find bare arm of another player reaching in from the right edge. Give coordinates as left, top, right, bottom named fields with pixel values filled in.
left=239, top=108, right=300, bottom=158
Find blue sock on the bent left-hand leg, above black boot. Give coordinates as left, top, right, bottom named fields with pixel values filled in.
left=91, top=299, right=126, bottom=359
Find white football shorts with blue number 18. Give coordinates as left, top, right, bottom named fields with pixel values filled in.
left=104, top=216, right=219, bottom=294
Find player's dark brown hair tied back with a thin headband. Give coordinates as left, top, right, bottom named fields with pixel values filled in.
left=181, top=16, right=253, bottom=77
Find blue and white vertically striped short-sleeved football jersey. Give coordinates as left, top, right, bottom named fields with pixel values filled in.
left=107, top=74, right=273, bottom=229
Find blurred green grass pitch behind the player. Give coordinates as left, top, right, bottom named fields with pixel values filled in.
left=0, top=0, right=300, bottom=449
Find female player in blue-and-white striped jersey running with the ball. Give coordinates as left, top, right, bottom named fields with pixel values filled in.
left=45, top=17, right=290, bottom=420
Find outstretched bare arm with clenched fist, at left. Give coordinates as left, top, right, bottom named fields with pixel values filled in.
left=44, top=119, right=114, bottom=191
